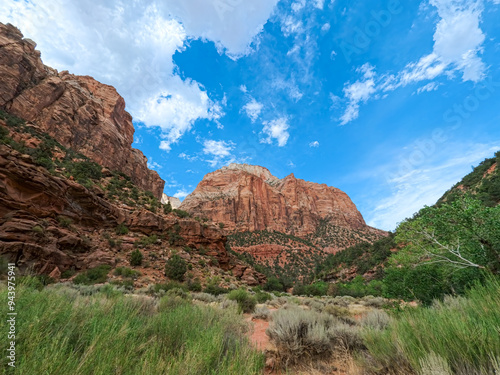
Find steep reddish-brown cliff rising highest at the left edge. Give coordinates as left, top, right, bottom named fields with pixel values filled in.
left=0, top=23, right=165, bottom=198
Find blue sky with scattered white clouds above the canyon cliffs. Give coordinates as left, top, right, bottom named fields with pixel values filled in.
left=0, top=0, right=500, bottom=230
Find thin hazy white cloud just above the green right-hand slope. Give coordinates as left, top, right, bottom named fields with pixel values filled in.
left=367, top=144, right=500, bottom=230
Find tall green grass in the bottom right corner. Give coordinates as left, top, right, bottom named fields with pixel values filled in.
left=364, top=279, right=500, bottom=375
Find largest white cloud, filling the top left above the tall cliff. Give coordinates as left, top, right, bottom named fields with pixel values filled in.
left=0, top=0, right=277, bottom=151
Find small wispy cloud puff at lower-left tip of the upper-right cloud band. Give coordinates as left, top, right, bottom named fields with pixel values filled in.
left=340, top=64, right=377, bottom=125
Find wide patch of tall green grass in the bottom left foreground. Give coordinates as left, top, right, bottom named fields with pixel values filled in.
left=0, top=286, right=264, bottom=375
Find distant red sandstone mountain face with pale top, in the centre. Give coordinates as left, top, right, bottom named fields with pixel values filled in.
left=181, top=164, right=367, bottom=237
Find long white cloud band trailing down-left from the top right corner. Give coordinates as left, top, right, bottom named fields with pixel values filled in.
left=341, top=0, right=490, bottom=125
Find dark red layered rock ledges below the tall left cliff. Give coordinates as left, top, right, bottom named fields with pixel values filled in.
left=0, top=144, right=265, bottom=285
